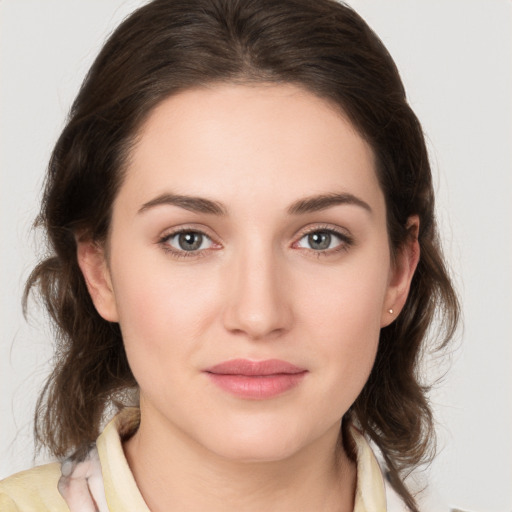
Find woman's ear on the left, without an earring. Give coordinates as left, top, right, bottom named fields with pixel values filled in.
left=76, top=238, right=118, bottom=322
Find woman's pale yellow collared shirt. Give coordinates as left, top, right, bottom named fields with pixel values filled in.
left=0, top=408, right=386, bottom=512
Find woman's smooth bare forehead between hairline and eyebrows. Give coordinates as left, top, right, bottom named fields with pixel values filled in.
left=120, top=84, right=383, bottom=218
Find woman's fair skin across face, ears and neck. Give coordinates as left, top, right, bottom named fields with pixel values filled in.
left=78, top=85, right=419, bottom=512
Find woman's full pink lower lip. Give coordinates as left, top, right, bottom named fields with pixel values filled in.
left=208, top=371, right=307, bottom=400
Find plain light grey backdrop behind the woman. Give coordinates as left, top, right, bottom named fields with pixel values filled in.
left=0, top=0, right=512, bottom=512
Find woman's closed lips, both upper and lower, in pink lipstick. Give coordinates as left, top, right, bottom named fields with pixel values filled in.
left=205, top=359, right=307, bottom=400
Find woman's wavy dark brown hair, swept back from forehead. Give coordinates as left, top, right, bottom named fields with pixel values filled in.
left=24, top=0, right=459, bottom=511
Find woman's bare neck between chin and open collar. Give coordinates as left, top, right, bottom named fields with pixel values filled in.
left=124, top=406, right=356, bottom=512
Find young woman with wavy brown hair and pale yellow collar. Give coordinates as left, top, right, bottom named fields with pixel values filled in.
left=0, top=0, right=458, bottom=512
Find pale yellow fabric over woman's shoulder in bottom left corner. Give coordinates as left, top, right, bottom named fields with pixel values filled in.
left=0, top=462, right=69, bottom=512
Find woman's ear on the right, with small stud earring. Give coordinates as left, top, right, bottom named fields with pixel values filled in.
left=380, top=215, right=420, bottom=327
